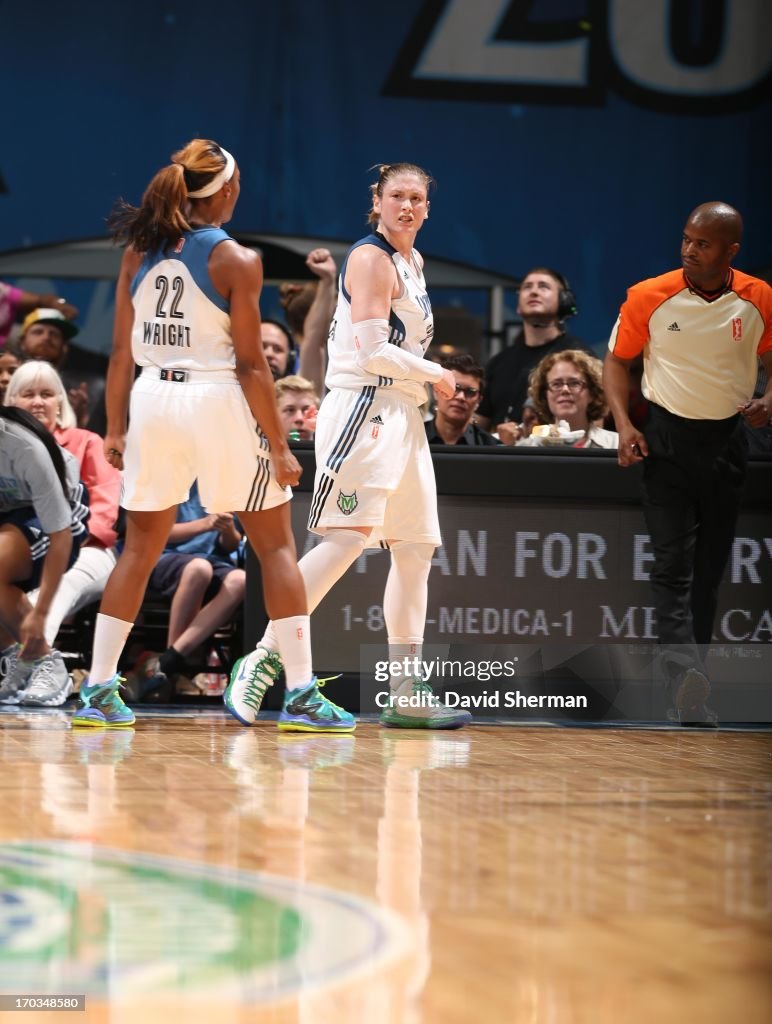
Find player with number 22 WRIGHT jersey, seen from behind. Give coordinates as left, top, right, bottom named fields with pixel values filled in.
left=73, top=139, right=354, bottom=732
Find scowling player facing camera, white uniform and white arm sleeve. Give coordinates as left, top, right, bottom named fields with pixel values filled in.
left=225, top=164, right=470, bottom=729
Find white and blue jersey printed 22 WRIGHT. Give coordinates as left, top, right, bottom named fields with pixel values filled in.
left=131, top=227, right=235, bottom=376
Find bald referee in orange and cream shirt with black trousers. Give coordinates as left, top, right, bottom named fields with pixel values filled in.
left=603, top=203, right=772, bottom=726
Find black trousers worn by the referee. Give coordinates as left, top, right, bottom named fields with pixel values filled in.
left=643, top=402, right=747, bottom=671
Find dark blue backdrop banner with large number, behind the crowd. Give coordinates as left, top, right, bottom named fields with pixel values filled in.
left=0, top=0, right=772, bottom=343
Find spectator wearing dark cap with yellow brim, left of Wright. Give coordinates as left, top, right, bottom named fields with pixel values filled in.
left=18, top=307, right=108, bottom=427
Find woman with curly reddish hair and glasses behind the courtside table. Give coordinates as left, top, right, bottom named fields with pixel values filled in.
left=517, top=348, right=619, bottom=449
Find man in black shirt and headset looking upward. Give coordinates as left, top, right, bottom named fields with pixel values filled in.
left=477, top=267, right=588, bottom=429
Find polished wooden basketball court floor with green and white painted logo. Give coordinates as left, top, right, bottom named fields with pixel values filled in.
left=0, top=708, right=772, bottom=1024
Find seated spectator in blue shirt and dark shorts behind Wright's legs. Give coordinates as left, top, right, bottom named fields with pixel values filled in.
left=133, top=482, right=247, bottom=699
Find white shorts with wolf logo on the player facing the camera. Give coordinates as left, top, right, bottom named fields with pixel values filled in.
left=308, top=386, right=442, bottom=548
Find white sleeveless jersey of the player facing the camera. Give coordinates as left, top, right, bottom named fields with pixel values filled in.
left=325, top=234, right=434, bottom=406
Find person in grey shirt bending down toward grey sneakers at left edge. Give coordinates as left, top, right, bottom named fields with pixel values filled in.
left=0, top=406, right=88, bottom=706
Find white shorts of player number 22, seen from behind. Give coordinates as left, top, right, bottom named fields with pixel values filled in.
left=121, top=368, right=292, bottom=512
